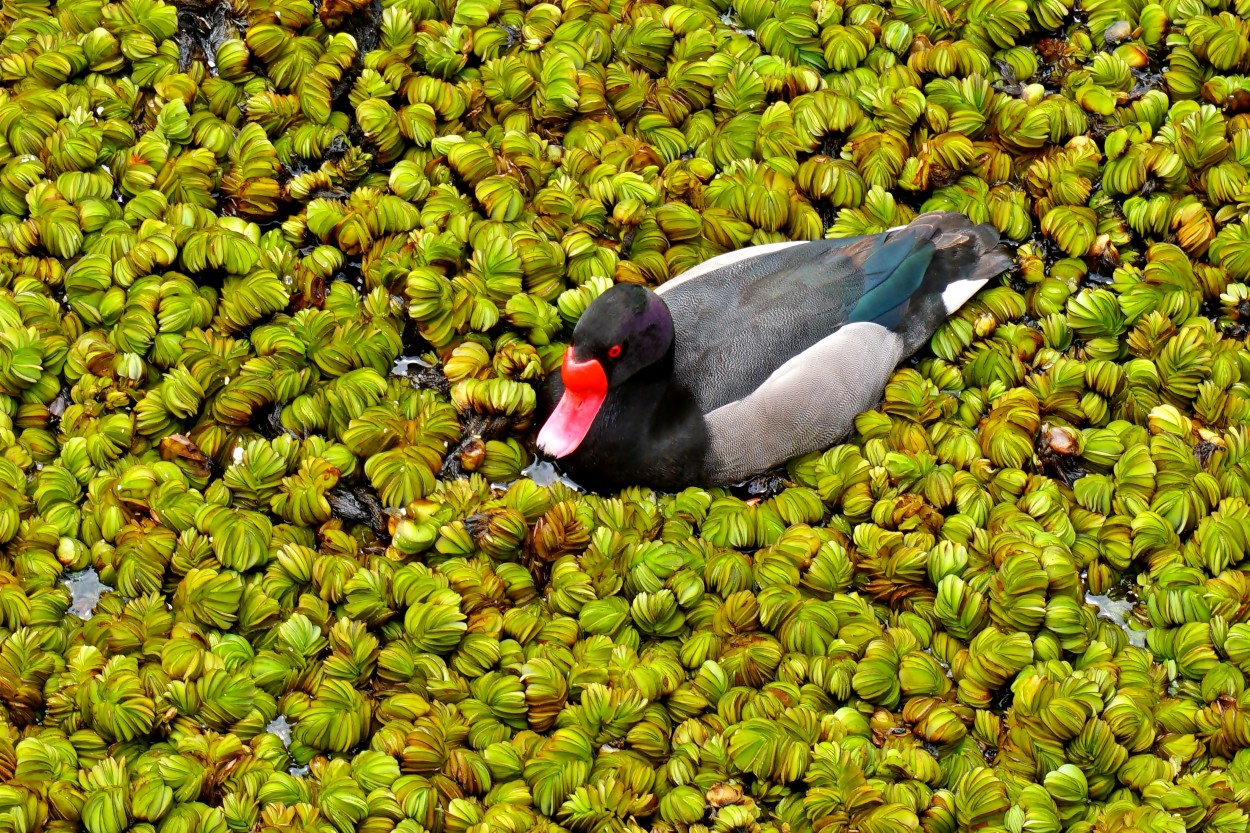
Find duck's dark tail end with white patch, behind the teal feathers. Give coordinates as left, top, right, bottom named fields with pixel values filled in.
left=870, top=211, right=1011, bottom=355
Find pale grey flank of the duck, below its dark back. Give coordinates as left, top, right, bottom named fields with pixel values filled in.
left=704, top=321, right=905, bottom=485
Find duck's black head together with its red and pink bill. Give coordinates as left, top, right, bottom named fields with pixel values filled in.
left=538, top=284, right=674, bottom=459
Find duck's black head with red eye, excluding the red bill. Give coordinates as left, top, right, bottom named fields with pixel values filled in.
left=573, top=284, right=674, bottom=388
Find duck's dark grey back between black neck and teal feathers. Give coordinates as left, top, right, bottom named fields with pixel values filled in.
left=659, top=238, right=895, bottom=413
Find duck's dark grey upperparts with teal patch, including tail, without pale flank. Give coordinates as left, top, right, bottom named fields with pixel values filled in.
left=659, top=213, right=1010, bottom=413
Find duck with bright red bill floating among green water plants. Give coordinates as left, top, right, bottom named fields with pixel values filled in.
left=536, top=211, right=1013, bottom=493
